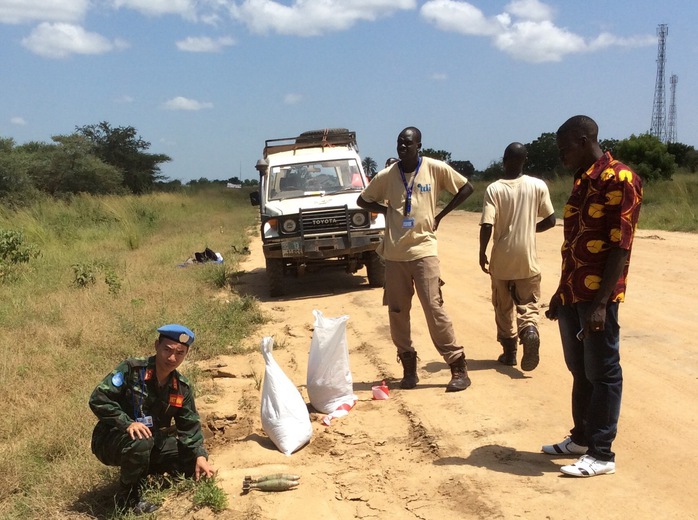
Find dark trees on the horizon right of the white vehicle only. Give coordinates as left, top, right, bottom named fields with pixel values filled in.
left=363, top=132, right=698, bottom=181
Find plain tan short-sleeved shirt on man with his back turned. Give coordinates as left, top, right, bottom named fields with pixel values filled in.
left=480, top=175, right=554, bottom=280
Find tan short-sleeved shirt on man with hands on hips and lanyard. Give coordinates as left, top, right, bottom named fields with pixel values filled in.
left=361, top=157, right=468, bottom=262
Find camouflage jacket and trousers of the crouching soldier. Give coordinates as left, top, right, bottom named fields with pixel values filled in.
left=90, top=356, right=208, bottom=486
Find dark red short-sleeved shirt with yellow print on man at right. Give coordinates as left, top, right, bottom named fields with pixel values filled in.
left=558, top=152, right=642, bottom=305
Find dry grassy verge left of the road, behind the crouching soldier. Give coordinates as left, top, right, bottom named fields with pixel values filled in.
left=0, top=188, right=265, bottom=519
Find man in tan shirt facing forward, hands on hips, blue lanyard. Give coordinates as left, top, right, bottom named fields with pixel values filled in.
left=357, top=127, right=473, bottom=392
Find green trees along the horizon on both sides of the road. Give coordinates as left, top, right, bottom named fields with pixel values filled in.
left=0, top=121, right=698, bottom=206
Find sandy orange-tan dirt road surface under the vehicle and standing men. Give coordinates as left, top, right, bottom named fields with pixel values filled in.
left=173, top=212, right=698, bottom=520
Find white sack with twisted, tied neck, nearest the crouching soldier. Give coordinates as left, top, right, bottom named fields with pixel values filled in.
left=260, top=336, right=313, bottom=455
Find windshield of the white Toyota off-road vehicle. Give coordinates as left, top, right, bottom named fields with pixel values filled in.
left=267, top=159, right=364, bottom=200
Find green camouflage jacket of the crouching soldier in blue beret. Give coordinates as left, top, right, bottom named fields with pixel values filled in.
left=90, top=356, right=208, bottom=458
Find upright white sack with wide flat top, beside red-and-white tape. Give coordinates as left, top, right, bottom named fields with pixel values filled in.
left=307, top=310, right=357, bottom=414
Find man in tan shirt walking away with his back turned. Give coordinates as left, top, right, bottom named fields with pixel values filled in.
left=480, top=143, right=555, bottom=371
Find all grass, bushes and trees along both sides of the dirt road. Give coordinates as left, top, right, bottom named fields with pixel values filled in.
left=0, top=122, right=698, bottom=520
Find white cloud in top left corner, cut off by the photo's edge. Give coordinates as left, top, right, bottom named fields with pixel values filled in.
left=0, top=0, right=90, bottom=23
